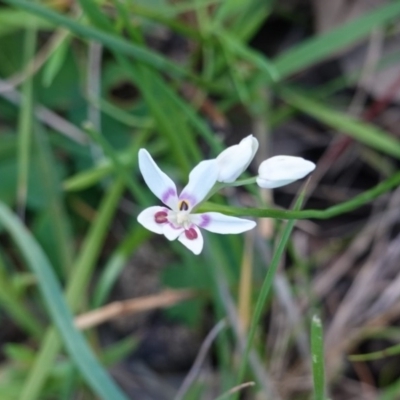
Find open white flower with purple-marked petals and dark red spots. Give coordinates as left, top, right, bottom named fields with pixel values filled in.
left=137, top=149, right=256, bottom=254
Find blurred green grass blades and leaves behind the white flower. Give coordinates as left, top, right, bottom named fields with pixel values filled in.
left=0, top=0, right=400, bottom=400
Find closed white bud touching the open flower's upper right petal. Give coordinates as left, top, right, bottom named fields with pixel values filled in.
left=217, top=135, right=258, bottom=183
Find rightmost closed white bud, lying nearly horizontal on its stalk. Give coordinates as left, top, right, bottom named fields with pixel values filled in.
left=257, top=156, right=315, bottom=189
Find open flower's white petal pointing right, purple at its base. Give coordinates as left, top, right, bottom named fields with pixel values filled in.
left=190, top=212, right=257, bottom=234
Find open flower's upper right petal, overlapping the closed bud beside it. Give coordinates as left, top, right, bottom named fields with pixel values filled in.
left=179, top=160, right=218, bottom=211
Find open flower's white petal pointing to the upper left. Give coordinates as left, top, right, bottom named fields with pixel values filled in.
left=139, top=149, right=178, bottom=209
